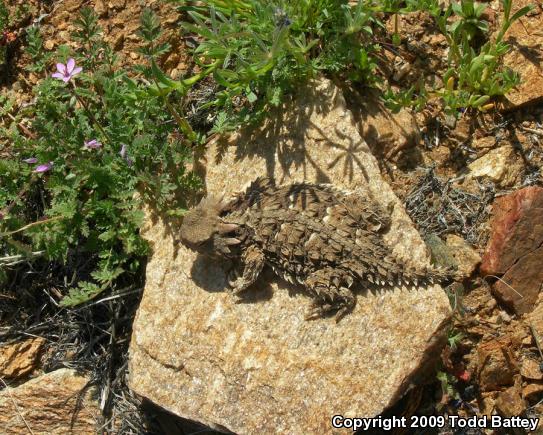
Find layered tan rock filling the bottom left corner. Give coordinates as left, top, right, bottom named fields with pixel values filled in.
left=0, top=369, right=100, bottom=434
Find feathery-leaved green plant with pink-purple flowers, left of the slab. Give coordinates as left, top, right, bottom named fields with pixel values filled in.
left=0, top=8, right=199, bottom=306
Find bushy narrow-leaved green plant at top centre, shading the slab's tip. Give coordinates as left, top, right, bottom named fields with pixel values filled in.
left=170, top=0, right=391, bottom=133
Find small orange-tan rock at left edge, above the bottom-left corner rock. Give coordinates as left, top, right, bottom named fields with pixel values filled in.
left=0, top=338, right=45, bottom=379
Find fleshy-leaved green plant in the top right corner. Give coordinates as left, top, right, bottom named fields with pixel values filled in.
left=385, top=0, right=532, bottom=115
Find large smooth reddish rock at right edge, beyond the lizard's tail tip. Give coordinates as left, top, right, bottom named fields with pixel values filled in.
left=481, top=186, right=543, bottom=275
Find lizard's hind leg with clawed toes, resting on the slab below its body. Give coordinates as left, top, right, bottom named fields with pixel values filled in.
left=304, top=267, right=356, bottom=322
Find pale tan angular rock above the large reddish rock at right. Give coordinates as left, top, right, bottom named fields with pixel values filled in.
left=468, top=145, right=522, bottom=187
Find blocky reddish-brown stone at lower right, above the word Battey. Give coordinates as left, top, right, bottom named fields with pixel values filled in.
left=477, top=339, right=518, bottom=391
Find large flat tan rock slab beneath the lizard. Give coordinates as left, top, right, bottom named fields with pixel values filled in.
left=129, top=81, right=450, bottom=434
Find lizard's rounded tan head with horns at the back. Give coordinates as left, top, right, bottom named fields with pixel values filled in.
left=180, top=198, right=241, bottom=256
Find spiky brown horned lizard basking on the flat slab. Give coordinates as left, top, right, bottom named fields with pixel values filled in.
left=180, top=178, right=448, bottom=320
